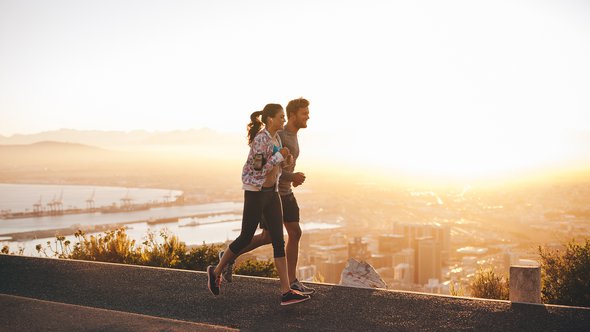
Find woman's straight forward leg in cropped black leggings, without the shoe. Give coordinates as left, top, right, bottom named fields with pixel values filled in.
left=264, top=192, right=291, bottom=294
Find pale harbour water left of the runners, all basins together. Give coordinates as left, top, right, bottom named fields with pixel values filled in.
left=0, top=184, right=340, bottom=256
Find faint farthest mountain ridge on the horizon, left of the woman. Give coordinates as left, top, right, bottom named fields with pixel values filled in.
left=0, top=128, right=245, bottom=148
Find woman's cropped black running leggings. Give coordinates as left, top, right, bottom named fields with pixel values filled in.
left=229, top=190, right=285, bottom=258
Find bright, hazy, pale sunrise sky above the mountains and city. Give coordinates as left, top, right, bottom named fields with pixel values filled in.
left=0, top=0, right=590, bottom=179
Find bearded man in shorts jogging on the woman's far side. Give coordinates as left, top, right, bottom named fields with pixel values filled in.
left=219, top=98, right=315, bottom=295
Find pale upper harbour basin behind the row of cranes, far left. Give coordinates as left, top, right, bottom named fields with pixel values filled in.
left=0, top=183, right=182, bottom=212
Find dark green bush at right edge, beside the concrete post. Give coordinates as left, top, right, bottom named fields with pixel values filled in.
left=539, top=240, right=590, bottom=307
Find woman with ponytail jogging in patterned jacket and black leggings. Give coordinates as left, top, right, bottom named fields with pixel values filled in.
left=207, top=104, right=310, bottom=305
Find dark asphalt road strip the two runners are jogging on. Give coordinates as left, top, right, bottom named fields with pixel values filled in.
left=0, top=255, right=590, bottom=331
